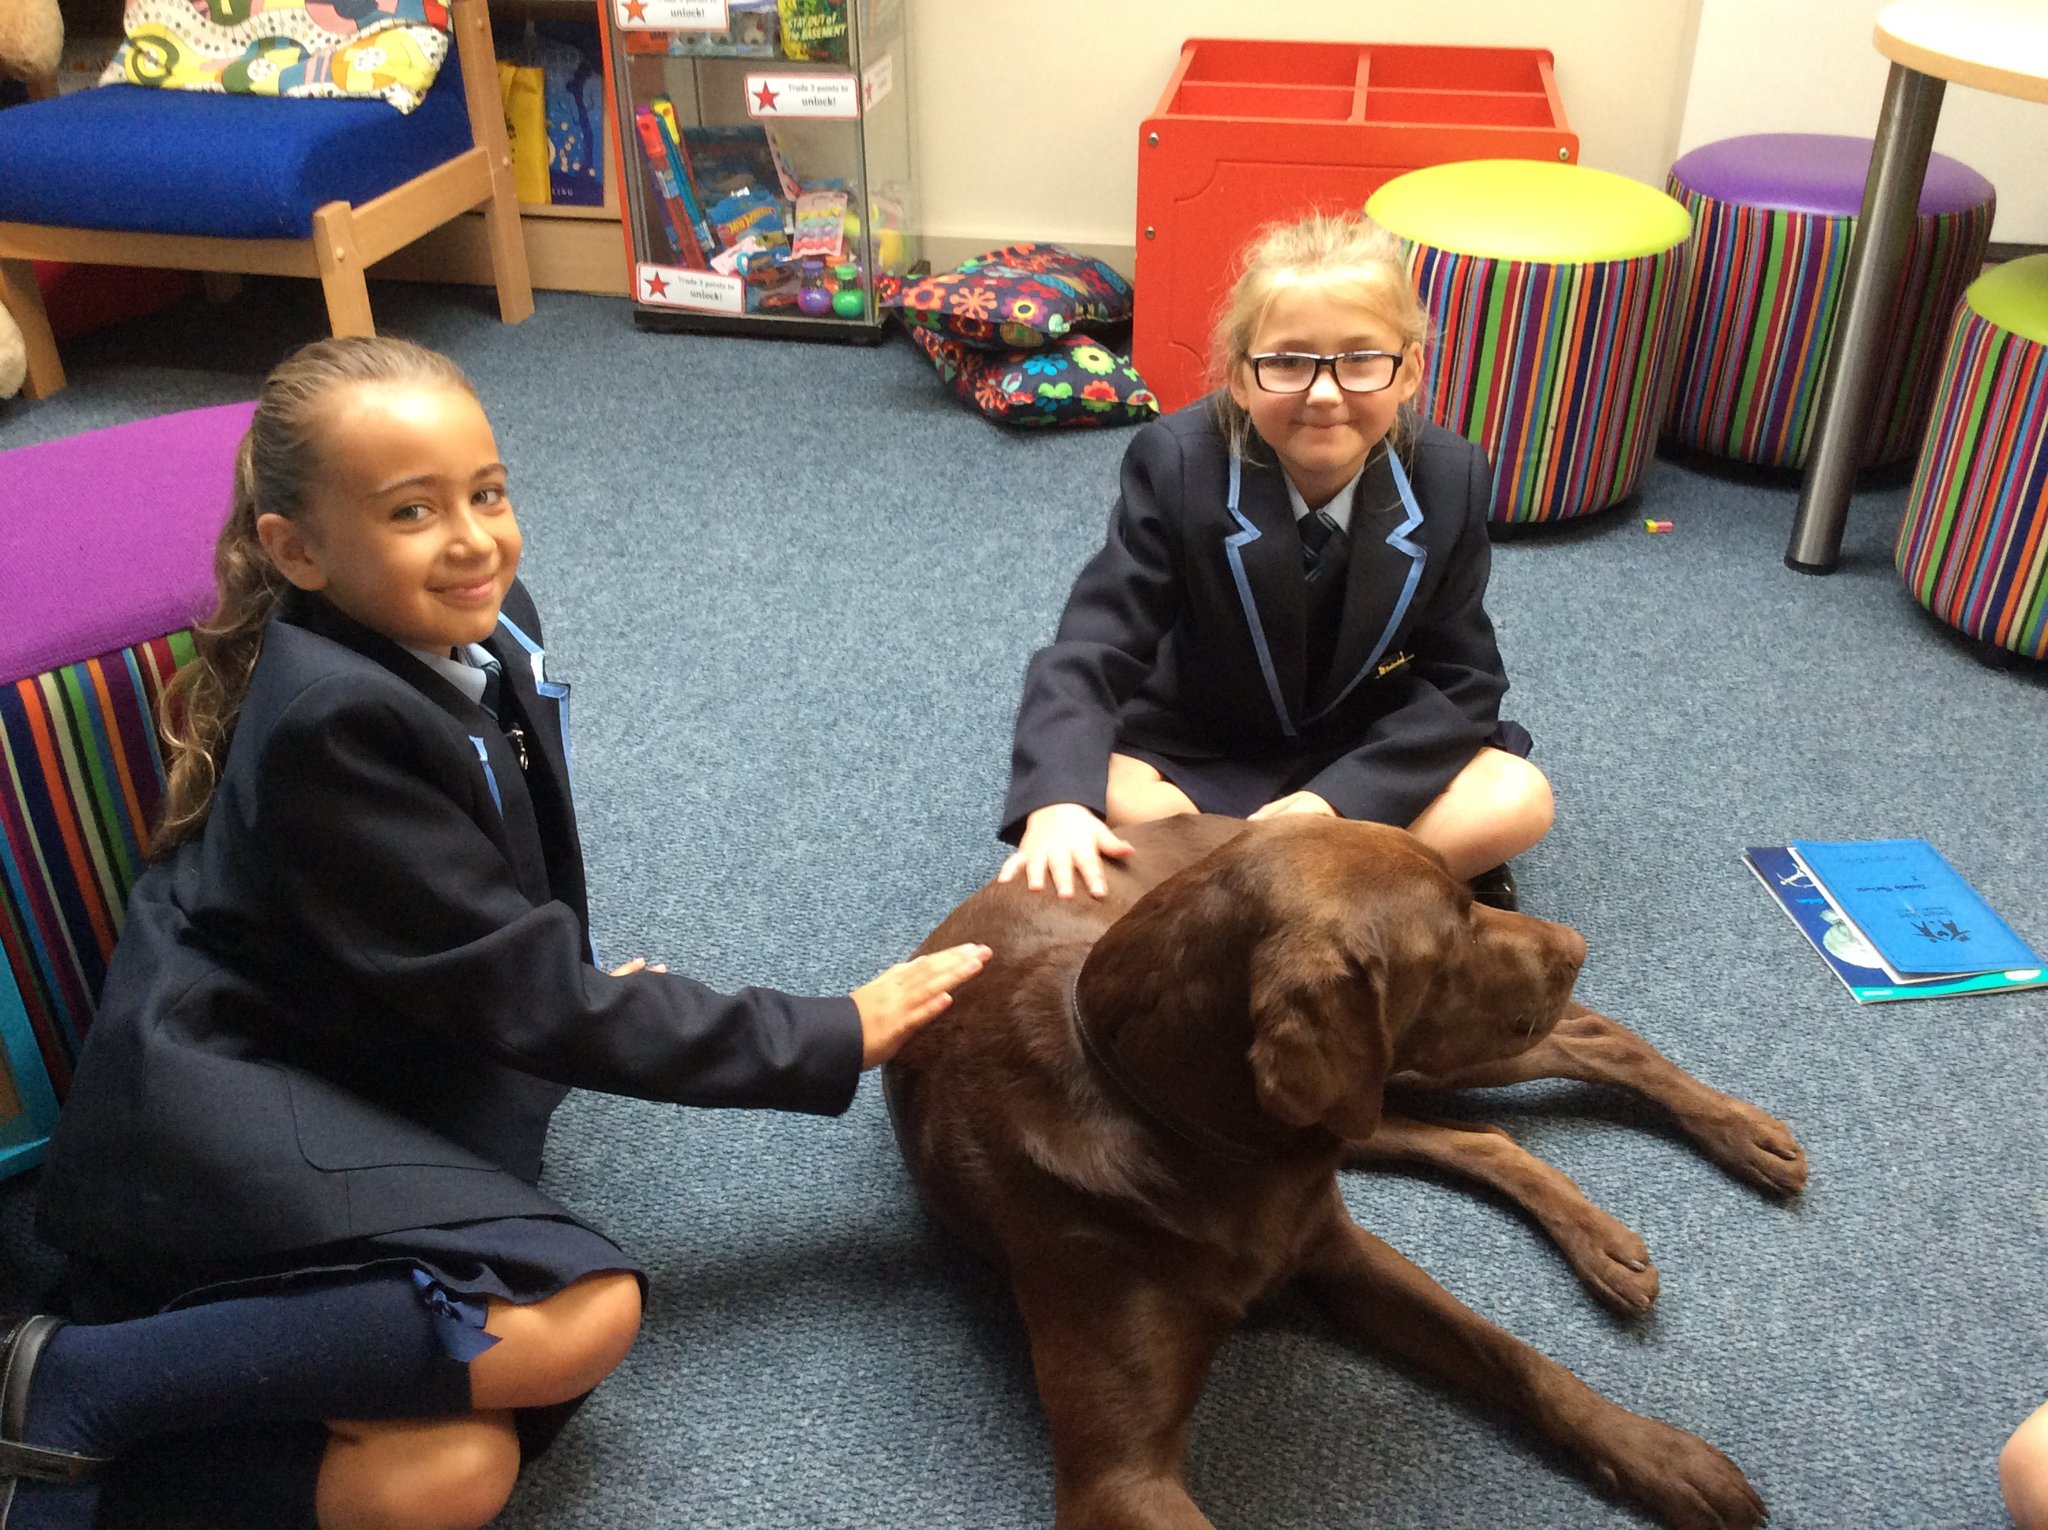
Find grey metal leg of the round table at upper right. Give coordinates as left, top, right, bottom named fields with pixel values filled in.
left=1786, top=63, right=1946, bottom=573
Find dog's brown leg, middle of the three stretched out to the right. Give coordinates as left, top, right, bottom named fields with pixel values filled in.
left=1346, top=1116, right=1657, bottom=1315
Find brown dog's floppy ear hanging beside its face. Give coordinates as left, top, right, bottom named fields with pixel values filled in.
left=1251, top=932, right=1393, bottom=1141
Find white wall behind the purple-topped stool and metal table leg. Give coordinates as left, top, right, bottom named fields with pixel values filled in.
left=1679, top=0, right=2048, bottom=244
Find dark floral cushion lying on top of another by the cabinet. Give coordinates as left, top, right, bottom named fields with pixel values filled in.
left=887, top=244, right=1130, bottom=350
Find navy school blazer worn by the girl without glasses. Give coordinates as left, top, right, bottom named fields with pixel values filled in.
left=39, top=584, right=860, bottom=1272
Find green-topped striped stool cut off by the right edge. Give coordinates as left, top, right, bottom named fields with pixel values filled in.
left=1894, top=254, right=2048, bottom=660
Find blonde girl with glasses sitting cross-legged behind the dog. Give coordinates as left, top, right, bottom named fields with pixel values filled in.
left=999, top=215, right=1552, bottom=907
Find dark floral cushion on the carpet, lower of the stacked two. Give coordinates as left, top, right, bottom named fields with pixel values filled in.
left=909, top=326, right=1159, bottom=426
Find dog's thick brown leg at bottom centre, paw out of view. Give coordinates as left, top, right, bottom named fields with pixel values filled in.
left=1012, top=1266, right=1235, bottom=1530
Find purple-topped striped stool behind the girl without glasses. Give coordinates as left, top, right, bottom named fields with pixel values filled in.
left=0, top=403, right=254, bottom=1096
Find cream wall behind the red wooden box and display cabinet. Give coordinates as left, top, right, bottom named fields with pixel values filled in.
left=909, top=0, right=1703, bottom=272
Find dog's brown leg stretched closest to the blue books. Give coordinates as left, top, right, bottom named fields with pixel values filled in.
left=1393, top=1004, right=1806, bottom=1196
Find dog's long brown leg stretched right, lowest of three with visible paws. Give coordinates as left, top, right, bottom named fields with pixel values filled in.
left=1300, top=1213, right=1763, bottom=1530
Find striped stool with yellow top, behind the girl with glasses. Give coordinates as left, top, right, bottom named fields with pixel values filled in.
left=1366, top=160, right=1692, bottom=522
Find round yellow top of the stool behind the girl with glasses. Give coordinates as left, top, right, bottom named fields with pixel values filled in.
left=1366, top=160, right=1692, bottom=266
